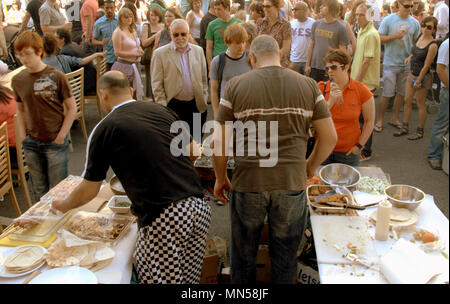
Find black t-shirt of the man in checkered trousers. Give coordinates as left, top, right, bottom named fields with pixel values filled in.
left=83, top=101, right=203, bottom=227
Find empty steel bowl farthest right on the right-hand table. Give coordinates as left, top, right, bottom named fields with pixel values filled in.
left=384, top=185, right=425, bottom=210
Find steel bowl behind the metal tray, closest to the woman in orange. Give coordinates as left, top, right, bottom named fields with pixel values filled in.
left=319, top=164, right=361, bottom=187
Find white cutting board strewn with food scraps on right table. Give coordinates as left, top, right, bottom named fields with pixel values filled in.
left=311, top=215, right=378, bottom=264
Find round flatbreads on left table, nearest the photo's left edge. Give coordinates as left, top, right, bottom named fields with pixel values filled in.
left=5, top=245, right=45, bottom=273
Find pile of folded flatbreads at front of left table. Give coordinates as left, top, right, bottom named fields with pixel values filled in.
left=45, top=230, right=115, bottom=270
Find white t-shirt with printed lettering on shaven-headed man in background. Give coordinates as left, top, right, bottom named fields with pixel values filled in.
left=290, top=18, right=315, bottom=62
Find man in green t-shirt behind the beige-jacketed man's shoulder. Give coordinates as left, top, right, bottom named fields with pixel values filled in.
left=205, top=0, right=242, bottom=70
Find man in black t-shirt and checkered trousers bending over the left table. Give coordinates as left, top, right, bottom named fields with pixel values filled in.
left=53, top=71, right=211, bottom=284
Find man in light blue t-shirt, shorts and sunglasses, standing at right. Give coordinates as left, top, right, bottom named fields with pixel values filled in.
left=374, top=0, right=420, bottom=132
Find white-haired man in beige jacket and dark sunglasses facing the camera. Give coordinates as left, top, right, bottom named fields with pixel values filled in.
left=151, top=19, right=208, bottom=140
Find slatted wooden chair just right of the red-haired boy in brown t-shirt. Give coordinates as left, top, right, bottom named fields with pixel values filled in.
left=66, top=68, right=87, bottom=152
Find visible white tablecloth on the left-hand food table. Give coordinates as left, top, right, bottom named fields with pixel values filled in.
left=0, top=223, right=137, bottom=284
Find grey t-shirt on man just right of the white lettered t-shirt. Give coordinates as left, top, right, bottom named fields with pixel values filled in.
left=311, top=19, right=349, bottom=70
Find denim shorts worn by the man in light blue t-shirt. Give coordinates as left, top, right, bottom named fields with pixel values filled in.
left=382, top=66, right=409, bottom=97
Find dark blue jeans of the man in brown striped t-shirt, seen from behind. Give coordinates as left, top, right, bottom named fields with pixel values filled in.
left=230, top=190, right=308, bottom=284
